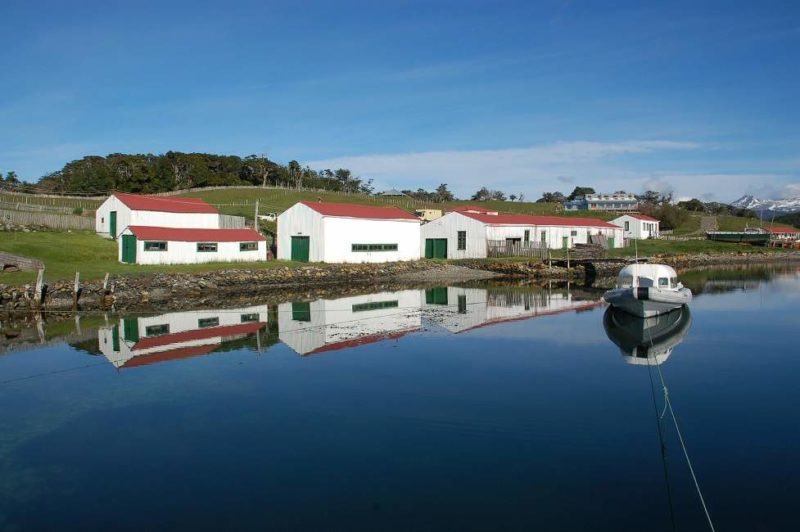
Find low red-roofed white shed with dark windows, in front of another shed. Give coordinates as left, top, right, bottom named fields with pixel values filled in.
left=118, top=225, right=267, bottom=264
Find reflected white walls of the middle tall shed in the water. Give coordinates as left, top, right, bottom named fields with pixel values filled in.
left=278, top=290, right=422, bottom=355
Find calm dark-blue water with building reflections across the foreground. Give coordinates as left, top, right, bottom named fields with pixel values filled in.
left=0, top=269, right=800, bottom=530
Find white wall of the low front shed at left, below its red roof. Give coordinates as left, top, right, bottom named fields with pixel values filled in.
left=117, top=230, right=267, bottom=264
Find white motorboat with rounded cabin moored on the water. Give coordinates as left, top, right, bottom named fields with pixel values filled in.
left=603, top=264, right=692, bottom=318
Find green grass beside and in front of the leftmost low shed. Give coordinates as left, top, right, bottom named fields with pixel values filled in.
left=0, top=231, right=307, bottom=285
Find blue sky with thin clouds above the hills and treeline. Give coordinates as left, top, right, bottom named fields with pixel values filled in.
left=0, top=0, right=800, bottom=200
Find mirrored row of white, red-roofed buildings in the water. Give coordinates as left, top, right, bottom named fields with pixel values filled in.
left=98, top=287, right=602, bottom=369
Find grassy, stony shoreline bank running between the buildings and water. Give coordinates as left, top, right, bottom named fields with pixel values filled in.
left=0, top=232, right=800, bottom=311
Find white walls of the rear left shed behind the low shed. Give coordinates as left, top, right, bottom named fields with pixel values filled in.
left=95, top=196, right=220, bottom=238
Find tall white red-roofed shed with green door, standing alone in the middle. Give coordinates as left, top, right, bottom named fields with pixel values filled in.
left=277, top=201, right=420, bottom=263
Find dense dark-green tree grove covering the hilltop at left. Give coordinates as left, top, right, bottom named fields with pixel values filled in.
left=28, top=151, right=372, bottom=194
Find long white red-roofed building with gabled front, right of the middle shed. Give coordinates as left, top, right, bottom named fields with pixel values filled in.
left=420, top=206, right=623, bottom=259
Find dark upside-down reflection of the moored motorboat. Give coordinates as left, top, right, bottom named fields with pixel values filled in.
left=603, top=305, right=692, bottom=365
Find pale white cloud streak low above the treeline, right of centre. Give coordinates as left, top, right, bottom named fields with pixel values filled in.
left=308, top=140, right=701, bottom=197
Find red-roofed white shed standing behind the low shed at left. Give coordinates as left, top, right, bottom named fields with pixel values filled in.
left=95, top=192, right=220, bottom=240
